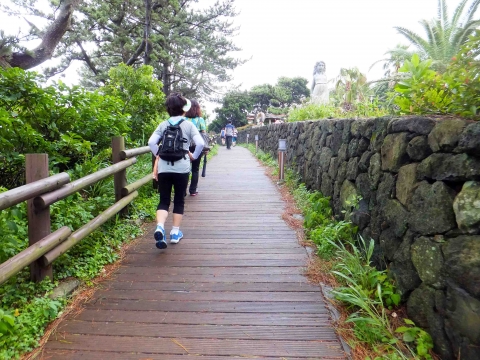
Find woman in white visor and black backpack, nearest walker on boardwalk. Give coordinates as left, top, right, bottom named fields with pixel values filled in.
left=148, top=93, right=204, bottom=249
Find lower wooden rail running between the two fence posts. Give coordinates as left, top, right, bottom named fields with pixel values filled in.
left=40, top=191, right=138, bottom=266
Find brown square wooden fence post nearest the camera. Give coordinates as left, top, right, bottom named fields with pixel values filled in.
left=25, top=154, right=53, bottom=282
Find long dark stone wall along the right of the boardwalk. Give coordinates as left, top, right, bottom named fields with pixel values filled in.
left=239, top=117, right=480, bottom=360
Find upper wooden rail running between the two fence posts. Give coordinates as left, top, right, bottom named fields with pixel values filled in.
left=33, top=158, right=137, bottom=209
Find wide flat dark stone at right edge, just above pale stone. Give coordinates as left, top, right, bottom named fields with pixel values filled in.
left=417, top=154, right=480, bottom=181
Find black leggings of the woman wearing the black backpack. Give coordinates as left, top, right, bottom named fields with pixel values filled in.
left=157, top=173, right=189, bottom=215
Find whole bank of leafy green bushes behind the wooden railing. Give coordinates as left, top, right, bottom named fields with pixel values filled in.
left=0, top=65, right=165, bottom=189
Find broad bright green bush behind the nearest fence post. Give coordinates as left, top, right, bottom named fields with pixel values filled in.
left=0, top=68, right=129, bottom=188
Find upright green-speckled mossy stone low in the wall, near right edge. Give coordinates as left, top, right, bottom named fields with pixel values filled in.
left=412, top=237, right=445, bottom=289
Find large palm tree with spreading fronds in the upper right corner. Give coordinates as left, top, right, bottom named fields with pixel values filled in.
left=391, top=0, right=480, bottom=70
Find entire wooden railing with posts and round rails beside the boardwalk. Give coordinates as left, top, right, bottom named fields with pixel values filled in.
left=0, top=136, right=152, bottom=284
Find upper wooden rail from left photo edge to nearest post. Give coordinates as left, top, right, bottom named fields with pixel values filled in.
left=0, top=173, right=70, bottom=210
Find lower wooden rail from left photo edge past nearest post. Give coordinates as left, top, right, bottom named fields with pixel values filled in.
left=0, top=226, right=72, bottom=285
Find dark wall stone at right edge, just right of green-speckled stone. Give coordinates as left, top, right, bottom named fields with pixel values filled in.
left=442, top=235, right=480, bottom=299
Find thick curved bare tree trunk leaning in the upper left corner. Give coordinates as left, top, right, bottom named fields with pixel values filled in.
left=7, top=0, right=82, bottom=70
